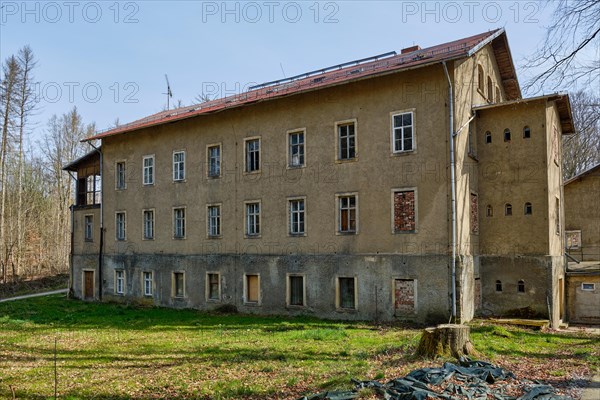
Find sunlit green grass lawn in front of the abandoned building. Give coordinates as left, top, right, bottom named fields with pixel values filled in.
left=0, top=295, right=600, bottom=399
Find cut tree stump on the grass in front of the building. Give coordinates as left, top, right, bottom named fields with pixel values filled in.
left=417, top=324, right=477, bottom=359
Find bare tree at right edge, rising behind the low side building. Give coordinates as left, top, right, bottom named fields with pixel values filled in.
left=563, top=91, right=600, bottom=180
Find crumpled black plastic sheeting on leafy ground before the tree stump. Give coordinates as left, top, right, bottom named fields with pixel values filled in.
left=298, top=357, right=573, bottom=400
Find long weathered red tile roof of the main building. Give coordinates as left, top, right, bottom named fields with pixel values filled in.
left=84, top=29, right=520, bottom=141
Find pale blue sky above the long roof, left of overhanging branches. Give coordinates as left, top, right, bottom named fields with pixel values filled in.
left=0, top=0, right=551, bottom=136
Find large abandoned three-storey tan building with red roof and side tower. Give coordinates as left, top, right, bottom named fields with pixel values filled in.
left=65, top=29, right=573, bottom=324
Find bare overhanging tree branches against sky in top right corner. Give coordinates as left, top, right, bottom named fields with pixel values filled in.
left=524, top=0, right=600, bottom=92
